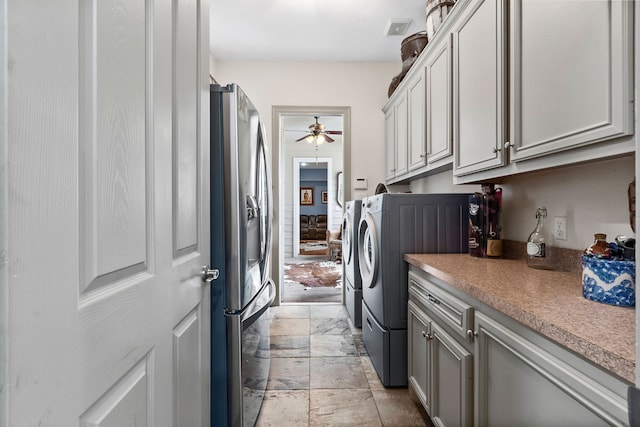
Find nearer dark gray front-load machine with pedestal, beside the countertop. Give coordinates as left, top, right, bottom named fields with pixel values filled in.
left=358, top=194, right=469, bottom=387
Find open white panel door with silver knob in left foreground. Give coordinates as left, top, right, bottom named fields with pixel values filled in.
left=0, top=0, right=209, bottom=427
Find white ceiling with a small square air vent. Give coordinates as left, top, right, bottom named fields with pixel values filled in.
left=210, top=0, right=426, bottom=62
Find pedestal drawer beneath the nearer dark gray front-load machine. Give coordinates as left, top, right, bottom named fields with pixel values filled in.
left=362, top=301, right=408, bottom=387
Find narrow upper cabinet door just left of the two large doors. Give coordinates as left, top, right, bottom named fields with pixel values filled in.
left=426, top=35, right=453, bottom=163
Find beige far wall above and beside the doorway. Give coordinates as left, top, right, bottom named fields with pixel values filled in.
left=210, top=60, right=402, bottom=193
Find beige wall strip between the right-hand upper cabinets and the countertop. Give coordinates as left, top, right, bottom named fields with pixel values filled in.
left=411, top=156, right=635, bottom=249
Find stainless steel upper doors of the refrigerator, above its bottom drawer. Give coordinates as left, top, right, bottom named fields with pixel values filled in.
left=222, top=84, right=271, bottom=311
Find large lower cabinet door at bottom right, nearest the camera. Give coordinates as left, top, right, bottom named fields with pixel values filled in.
left=474, top=313, right=628, bottom=426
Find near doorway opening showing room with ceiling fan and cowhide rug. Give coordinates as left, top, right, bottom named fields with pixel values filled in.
left=272, top=106, right=351, bottom=304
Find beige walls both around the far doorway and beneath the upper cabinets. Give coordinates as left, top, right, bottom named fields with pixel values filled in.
left=212, top=56, right=635, bottom=254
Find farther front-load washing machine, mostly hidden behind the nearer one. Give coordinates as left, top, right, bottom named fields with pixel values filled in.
left=342, top=200, right=362, bottom=328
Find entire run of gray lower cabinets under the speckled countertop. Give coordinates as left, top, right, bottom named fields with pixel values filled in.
left=408, top=266, right=628, bottom=427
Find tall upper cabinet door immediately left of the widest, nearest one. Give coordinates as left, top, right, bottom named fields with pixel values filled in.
left=452, top=0, right=508, bottom=176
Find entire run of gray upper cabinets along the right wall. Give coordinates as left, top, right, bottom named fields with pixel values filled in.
left=383, top=0, right=635, bottom=184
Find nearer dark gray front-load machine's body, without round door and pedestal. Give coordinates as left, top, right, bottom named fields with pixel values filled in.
left=362, top=194, right=469, bottom=329
